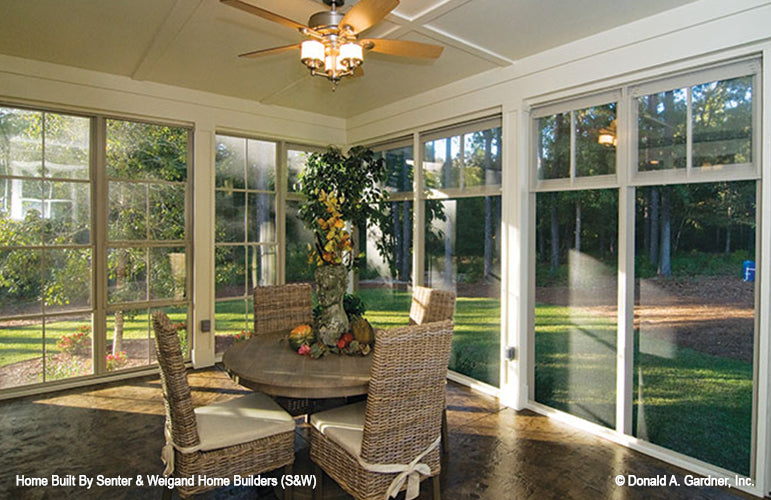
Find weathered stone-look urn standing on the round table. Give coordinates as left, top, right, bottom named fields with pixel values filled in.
left=316, top=264, right=348, bottom=346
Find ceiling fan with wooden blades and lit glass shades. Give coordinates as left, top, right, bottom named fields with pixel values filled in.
left=220, top=0, right=443, bottom=90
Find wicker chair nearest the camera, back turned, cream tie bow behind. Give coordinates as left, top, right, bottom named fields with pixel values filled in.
left=311, top=321, right=453, bottom=500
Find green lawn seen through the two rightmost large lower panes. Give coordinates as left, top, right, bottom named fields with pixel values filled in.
left=535, top=305, right=752, bottom=474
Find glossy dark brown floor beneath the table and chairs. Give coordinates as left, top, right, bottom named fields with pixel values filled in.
left=0, top=368, right=753, bottom=500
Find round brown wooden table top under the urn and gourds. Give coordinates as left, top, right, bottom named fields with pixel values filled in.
left=222, top=333, right=372, bottom=399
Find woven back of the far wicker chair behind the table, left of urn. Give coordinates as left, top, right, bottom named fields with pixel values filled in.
left=254, top=283, right=313, bottom=335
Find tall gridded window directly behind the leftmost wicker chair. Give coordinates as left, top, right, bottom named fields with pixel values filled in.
left=105, top=119, right=191, bottom=369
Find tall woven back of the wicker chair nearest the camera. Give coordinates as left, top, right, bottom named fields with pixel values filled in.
left=361, top=320, right=453, bottom=468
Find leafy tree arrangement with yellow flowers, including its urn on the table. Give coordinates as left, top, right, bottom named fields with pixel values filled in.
left=298, top=146, right=388, bottom=346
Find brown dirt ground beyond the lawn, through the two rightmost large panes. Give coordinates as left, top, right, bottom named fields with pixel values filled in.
left=536, top=277, right=755, bottom=362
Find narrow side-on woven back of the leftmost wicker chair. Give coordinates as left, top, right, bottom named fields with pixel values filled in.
left=153, top=312, right=200, bottom=447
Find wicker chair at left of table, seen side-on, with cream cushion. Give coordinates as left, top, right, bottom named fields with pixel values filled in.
left=153, top=312, right=295, bottom=498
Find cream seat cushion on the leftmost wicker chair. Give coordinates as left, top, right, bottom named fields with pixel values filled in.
left=195, top=392, right=294, bottom=451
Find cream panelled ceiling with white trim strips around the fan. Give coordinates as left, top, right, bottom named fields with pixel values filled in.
left=0, top=0, right=694, bottom=118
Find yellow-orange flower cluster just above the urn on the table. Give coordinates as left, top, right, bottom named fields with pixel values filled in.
left=309, top=189, right=353, bottom=266
